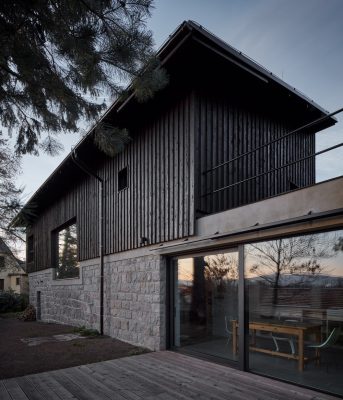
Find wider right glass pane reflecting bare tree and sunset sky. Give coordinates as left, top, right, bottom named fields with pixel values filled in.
left=245, top=231, right=343, bottom=394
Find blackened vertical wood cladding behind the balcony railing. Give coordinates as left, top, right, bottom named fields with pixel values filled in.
left=195, top=93, right=315, bottom=217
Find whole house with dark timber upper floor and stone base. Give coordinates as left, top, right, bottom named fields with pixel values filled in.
left=17, top=21, right=343, bottom=395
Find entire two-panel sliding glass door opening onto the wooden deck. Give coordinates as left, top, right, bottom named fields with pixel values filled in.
left=171, top=230, right=343, bottom=396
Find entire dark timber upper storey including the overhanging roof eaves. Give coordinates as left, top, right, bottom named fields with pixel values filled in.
left=22, top=23, right=334, bottom=271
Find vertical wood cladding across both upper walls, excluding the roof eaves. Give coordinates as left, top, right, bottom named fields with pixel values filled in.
left=27, top=89, right=315, bottom=271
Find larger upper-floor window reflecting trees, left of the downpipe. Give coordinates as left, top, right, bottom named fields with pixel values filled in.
left=53, top=222, right=79, bottom=279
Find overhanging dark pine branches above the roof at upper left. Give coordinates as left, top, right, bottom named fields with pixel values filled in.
left=0, top=0, right=167, bottom=155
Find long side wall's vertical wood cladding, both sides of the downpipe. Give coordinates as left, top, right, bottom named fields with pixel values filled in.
left=30, top=95, right=194, bottom=271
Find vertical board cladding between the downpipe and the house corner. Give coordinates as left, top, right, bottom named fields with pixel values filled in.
left=103, top=91, right=194, bottom=254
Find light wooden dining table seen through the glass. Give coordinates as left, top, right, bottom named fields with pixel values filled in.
left=232, top=320, right=321, bottom=371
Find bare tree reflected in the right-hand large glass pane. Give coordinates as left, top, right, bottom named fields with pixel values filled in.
left=248, top=235, right=332, bottom=304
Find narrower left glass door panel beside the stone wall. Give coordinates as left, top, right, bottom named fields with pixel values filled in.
left=173, top=251, right=238, bottom=361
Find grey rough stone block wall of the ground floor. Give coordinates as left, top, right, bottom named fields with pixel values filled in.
left=29, top=250, right=166, bottom=350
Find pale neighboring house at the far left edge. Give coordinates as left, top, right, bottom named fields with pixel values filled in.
left=0, top=238, right=29, bottom=294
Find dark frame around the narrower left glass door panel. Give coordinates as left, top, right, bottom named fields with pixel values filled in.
left=166, top=244, right=249, bottom=371
